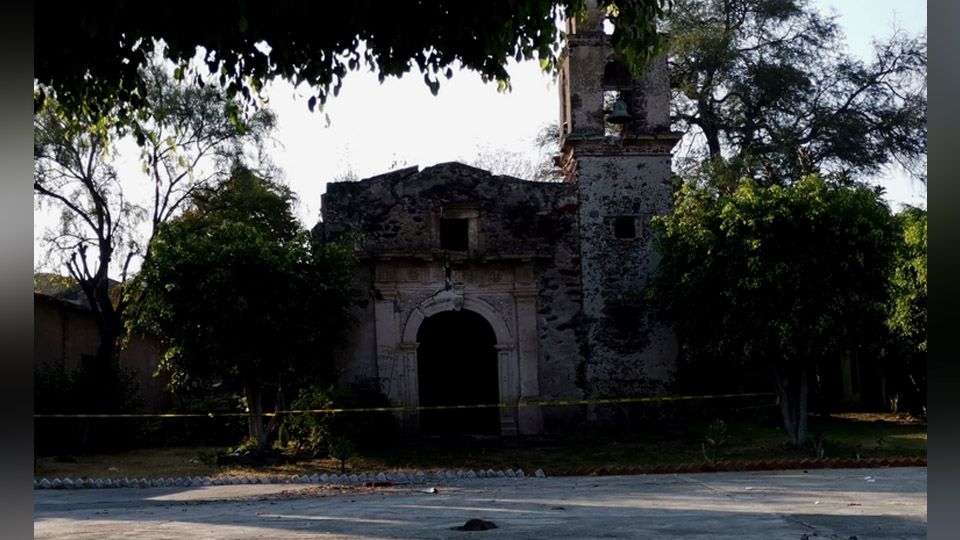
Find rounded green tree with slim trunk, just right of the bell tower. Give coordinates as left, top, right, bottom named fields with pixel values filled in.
left=649, top=175, right=897, bottom=445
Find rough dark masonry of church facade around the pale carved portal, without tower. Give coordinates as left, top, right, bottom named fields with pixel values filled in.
left=317, top=163, right=584, bottom=429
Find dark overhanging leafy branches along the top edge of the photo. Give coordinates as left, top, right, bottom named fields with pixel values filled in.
left=34, top=0, right=667, bottom=123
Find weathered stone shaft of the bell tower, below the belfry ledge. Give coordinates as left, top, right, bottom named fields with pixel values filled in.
left=577, top=148, right=676, bottom=397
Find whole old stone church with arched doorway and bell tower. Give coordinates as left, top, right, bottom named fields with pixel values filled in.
left=317, top=8, right=679, bottom=435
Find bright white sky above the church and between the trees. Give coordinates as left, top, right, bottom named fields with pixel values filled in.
left=34, top=0, right=926, bottom=278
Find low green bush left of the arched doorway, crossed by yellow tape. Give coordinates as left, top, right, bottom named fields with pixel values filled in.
left=283, top=384, right=398, bottom=457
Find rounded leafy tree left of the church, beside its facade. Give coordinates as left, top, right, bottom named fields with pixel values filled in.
left=130, top=168, right=354, bottom=448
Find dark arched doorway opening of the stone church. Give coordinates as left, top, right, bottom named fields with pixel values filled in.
left=417, top=309, right=500, bottom=435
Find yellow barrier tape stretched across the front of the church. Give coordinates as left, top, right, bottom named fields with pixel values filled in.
left=33, top=392, right=776, bottom=418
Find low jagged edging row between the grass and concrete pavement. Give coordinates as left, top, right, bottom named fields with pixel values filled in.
left=33, top=458, right=927, bottom=489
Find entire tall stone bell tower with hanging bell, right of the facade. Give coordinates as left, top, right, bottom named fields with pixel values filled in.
left=559, top=1, right=681, bottom=404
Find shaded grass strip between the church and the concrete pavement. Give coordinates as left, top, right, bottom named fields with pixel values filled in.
left=34, top=414, right=927, bottom=479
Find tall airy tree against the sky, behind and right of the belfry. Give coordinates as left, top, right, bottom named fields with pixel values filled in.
left=667, top=0, right=927, bottom=187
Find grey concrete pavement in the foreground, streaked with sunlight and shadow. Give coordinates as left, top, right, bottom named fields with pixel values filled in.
left=34, top=467, right=927, bottom=540
